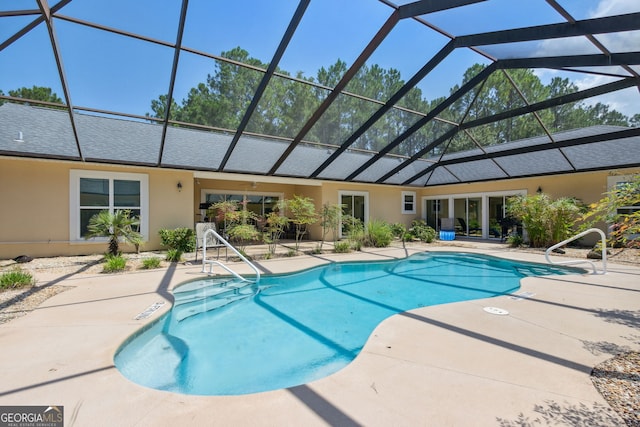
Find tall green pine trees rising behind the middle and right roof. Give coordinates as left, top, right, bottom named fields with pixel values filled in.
left=148, top=47, right=640, bottom=156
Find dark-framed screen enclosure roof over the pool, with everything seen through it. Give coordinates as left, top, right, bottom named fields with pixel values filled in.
left=0, top=0, right=640, bottom=186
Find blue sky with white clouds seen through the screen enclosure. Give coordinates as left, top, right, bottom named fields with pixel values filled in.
left=0, top=0, right=640, bottom=115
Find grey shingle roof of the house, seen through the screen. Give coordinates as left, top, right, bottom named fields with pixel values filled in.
left=0, top=103, right=640, bottom=186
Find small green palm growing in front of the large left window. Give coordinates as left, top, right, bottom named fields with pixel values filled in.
left=85, top=209, right=142, bottom=256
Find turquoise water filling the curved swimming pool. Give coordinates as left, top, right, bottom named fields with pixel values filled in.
left=115, top=252, right=582, bottom=395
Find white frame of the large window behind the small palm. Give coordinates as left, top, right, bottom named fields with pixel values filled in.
left=69, top=169, right=149, bottom=243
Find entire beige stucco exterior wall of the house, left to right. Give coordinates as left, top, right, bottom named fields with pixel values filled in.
left=0, top=157, right=640, bottom=259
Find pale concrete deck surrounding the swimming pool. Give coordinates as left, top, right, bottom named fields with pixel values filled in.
left=0, top=244, right=640, bottom=427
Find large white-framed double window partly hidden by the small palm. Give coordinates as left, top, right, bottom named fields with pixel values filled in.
left=69, top=170, right=149, bottom=241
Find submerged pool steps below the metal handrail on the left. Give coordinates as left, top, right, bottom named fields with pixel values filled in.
left=172, top=279, right=257, bottom=322
